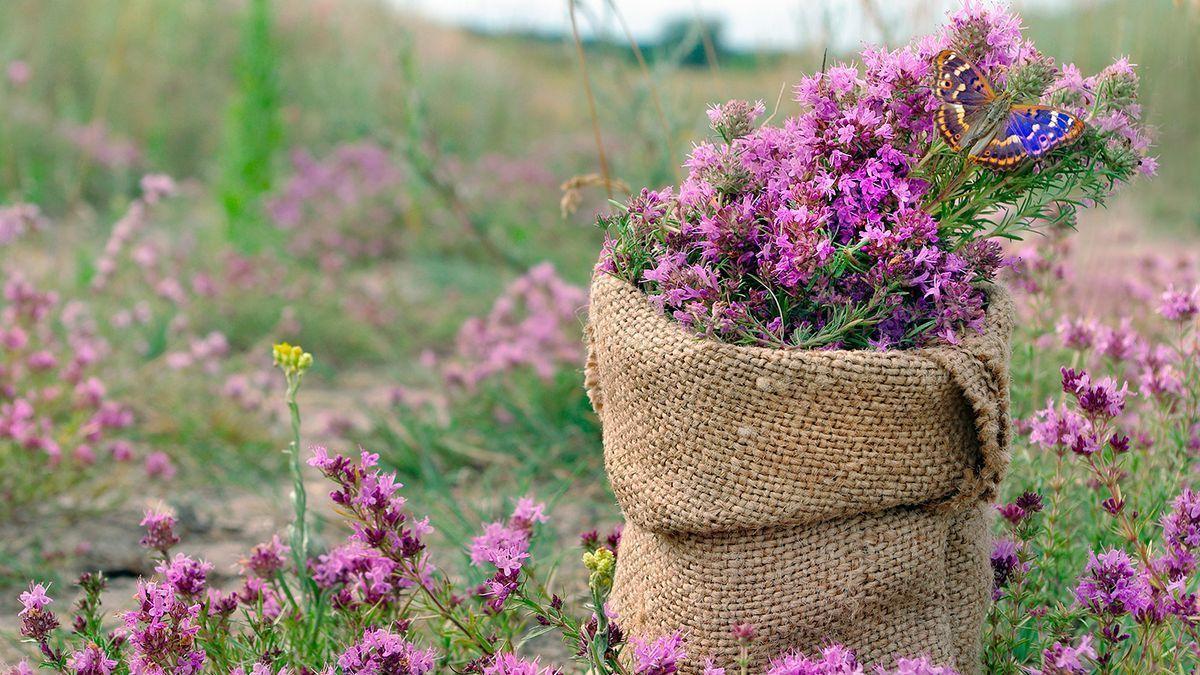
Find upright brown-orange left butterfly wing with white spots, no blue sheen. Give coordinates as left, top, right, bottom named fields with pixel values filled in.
left=934, top=49, right=996, bottom=153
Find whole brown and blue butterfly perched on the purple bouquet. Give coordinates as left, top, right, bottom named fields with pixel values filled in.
left=934, top=49, right=1084, bottom=169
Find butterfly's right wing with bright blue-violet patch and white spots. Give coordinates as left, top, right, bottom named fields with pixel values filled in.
left=972, top=106, right=1084, bottom=169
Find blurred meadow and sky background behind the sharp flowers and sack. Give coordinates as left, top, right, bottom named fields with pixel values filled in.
left=0, top=0, right=1200, bottom=638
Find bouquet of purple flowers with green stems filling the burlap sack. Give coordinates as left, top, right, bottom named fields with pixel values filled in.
left=598, top=5, right=1157, bottom=350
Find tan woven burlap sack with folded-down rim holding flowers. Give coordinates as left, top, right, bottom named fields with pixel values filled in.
left=587, top=274, right=1013, bottom=674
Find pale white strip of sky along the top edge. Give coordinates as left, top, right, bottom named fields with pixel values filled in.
left=391, top=0, right=1070, bottom=50
